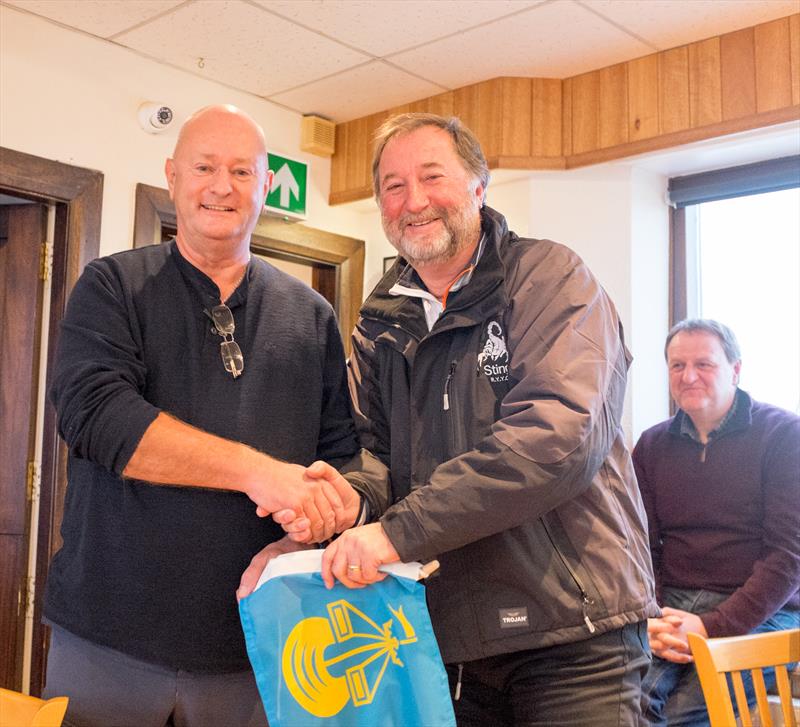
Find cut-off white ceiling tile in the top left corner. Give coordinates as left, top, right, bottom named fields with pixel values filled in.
left=5, top=0, right=183, bottom=38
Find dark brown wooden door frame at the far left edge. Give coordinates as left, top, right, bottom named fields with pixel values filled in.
left=0, top=147, right=103, bottom=695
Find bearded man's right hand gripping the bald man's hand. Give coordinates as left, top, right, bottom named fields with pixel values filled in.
left=272, top=461, right=361, bottom=543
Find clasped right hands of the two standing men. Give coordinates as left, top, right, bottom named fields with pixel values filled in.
left=245, top=460, right=361, bottom=543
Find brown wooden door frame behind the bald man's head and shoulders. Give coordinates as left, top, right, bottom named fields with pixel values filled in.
left=133, top=184, right=364, bottom=354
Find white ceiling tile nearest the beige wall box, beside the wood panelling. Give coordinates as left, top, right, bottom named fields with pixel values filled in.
left=270, top=61, right=444, bottom=122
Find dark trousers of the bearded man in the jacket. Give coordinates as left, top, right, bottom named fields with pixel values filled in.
left=447, top=621, right=650, bottom=727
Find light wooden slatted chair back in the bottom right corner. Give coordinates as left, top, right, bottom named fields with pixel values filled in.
left=689, top=629, right=800, bottom=727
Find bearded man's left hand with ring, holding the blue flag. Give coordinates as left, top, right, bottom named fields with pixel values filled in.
left=322, top=523, right=400, bottom=588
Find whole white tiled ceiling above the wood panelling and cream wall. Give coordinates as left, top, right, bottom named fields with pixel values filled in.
left=2, top=0, right=800, bottom=121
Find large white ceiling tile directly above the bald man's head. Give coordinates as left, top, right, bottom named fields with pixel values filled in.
left=115, top=0, right=369, bottom=96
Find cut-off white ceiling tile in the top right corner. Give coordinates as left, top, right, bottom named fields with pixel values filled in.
left=584, top=0, right=800, bottom=50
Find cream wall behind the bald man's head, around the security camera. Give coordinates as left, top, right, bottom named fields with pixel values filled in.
left=0, top=6, right=358, bottom=255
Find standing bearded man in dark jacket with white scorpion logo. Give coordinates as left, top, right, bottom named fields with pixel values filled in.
left=276, top=114, right=658, bottom=727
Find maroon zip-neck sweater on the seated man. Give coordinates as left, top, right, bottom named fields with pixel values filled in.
left=633, top=390, right=800, bottom=637
